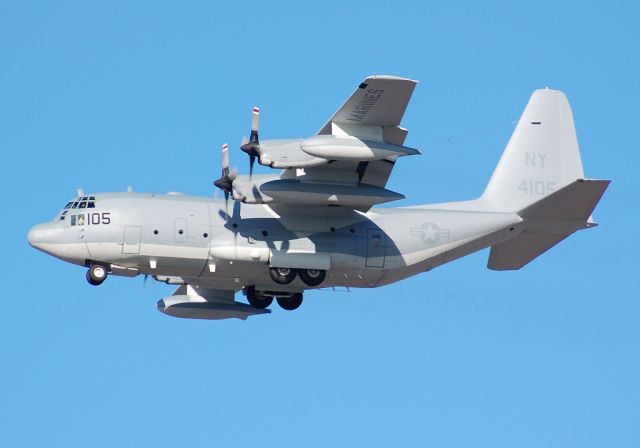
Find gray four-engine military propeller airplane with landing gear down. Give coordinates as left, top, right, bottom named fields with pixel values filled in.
left=28, top=76, right=610, bottom=319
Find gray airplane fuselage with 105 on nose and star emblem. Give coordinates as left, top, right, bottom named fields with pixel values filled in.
left=29, top=193, right=521, bottom=292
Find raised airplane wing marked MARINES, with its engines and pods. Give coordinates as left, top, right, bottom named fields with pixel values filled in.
left=228, top=76, right=420, bottom=211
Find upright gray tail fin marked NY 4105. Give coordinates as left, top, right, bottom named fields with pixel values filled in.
left=481, top=89, right=584, bottom=212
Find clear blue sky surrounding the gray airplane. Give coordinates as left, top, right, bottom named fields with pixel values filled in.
left=0, top=0, right=640, bottom=448
